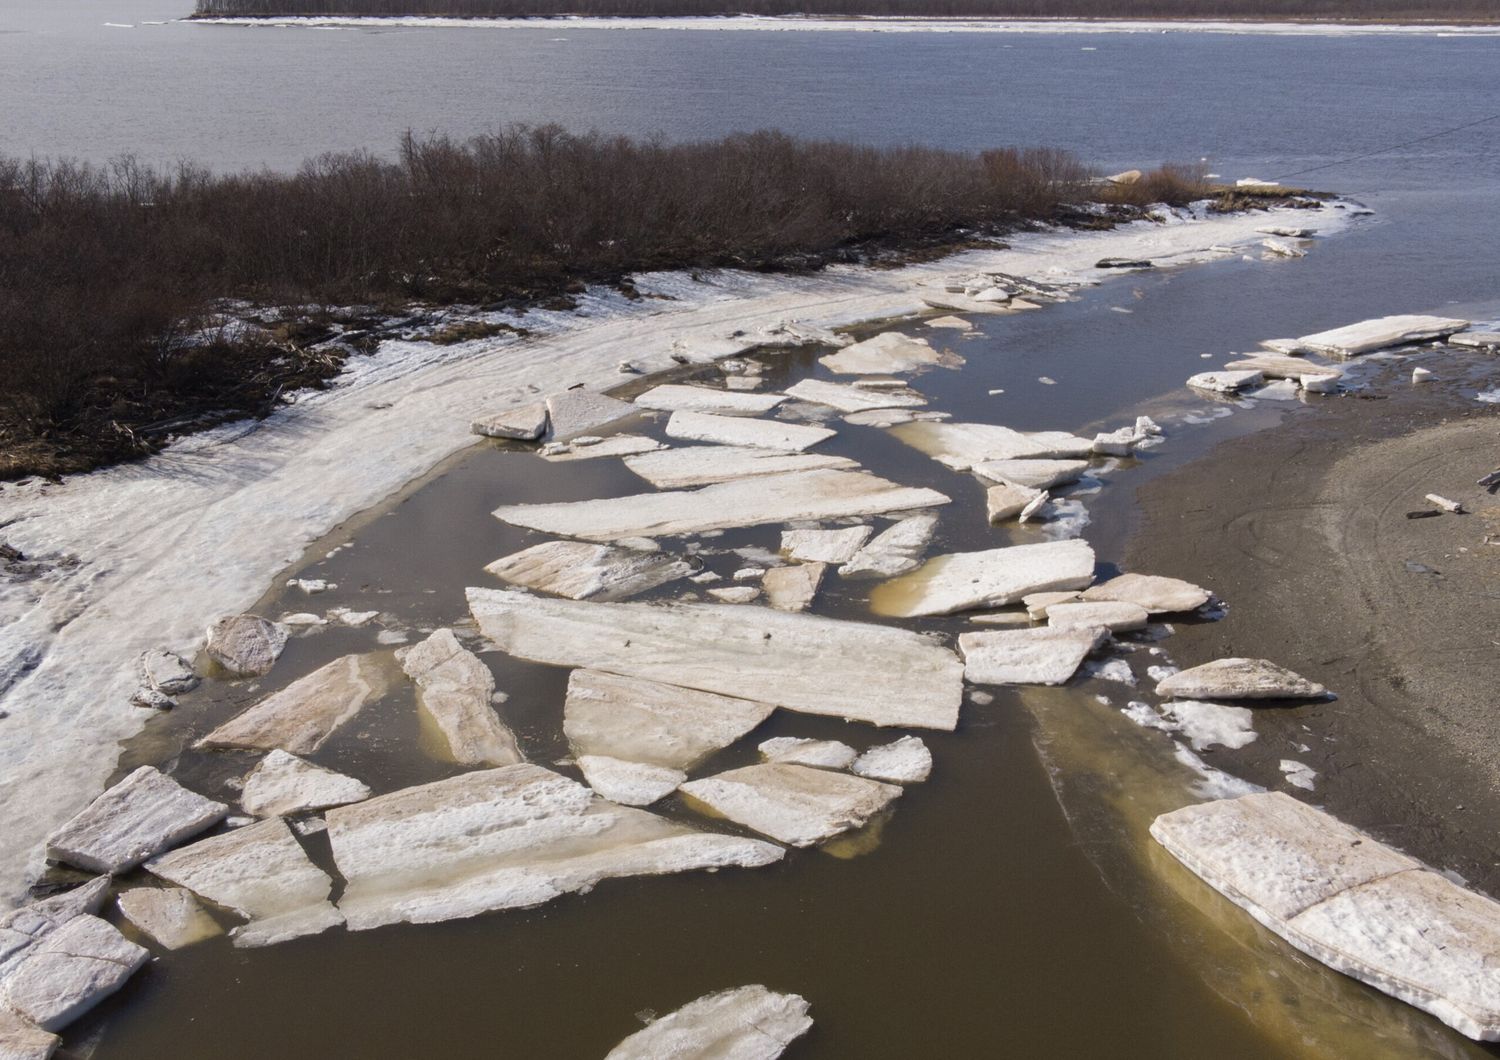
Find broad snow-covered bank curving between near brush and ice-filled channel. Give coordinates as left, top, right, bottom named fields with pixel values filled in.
left=0, top=208, right=1347, bottom=900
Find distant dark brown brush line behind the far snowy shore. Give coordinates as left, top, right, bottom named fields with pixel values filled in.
left=187, top=0, right=1497, bottom=21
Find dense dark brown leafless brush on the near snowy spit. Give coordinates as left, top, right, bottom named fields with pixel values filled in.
left=0, top=127, right=1200, bottom=477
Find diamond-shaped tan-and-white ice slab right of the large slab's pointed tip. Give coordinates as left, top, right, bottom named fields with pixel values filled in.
left=681, top=762, right=902, bottom=847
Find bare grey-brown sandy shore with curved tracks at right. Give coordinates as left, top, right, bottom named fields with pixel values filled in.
left=1127, top=354, right=1500, bottom=894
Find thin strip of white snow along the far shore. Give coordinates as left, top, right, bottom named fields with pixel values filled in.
left=183, top=15, right=1500, bottom=36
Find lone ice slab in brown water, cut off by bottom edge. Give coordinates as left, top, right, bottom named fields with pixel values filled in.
left=605, top=987, right=813, bottom=1060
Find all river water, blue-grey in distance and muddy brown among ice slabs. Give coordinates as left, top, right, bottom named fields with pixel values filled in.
left=0, top=0, right=1500, bottom=1060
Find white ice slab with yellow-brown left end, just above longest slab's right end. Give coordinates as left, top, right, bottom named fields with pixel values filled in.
left=870, top=538, right=1094, bottom=618
